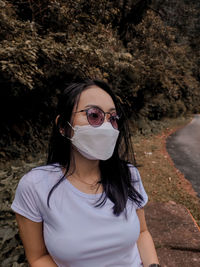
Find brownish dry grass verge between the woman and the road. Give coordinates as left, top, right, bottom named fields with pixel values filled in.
left=130, top=116, right=200, bottom=226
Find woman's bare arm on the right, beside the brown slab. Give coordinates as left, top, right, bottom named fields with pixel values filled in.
left=137, top=209, right=159, bottom=267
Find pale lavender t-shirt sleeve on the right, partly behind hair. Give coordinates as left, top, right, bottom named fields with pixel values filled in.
left=130, top=166, right=148, bottom=209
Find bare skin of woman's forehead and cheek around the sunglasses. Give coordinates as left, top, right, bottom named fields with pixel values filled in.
left=71, top=85, right=116, bottom=126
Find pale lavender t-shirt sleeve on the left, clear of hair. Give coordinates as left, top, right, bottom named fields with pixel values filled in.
left=11, top=173, right=42, bottom=222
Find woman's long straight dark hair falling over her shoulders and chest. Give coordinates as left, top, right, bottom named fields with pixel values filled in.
left=47, top=79, right=143, bottom=216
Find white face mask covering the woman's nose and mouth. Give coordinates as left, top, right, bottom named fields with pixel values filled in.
left=70, top=122, right=119, bottom=160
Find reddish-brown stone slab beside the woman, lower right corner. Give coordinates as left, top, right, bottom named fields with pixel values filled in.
left=145, top=201, right=200, bottom=267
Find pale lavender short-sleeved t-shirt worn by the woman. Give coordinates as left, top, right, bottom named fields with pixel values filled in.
left=11, top=165, right=148, bottom=267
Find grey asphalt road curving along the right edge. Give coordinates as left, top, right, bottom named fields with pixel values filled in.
left=166, top=115, right=200, bottom=197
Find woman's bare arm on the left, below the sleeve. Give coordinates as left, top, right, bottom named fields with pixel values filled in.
left=16, top=213, right=57, bottom=267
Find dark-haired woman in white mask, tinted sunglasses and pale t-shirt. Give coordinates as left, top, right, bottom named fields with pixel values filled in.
left=11, top=80, right=159, bottom=267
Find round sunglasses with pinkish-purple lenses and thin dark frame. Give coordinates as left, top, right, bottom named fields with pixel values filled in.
left=74, top=107, right=120, bottom=129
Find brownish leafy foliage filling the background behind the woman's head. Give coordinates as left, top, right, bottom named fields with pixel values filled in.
left=0, top=0, right=200, bottom=152
